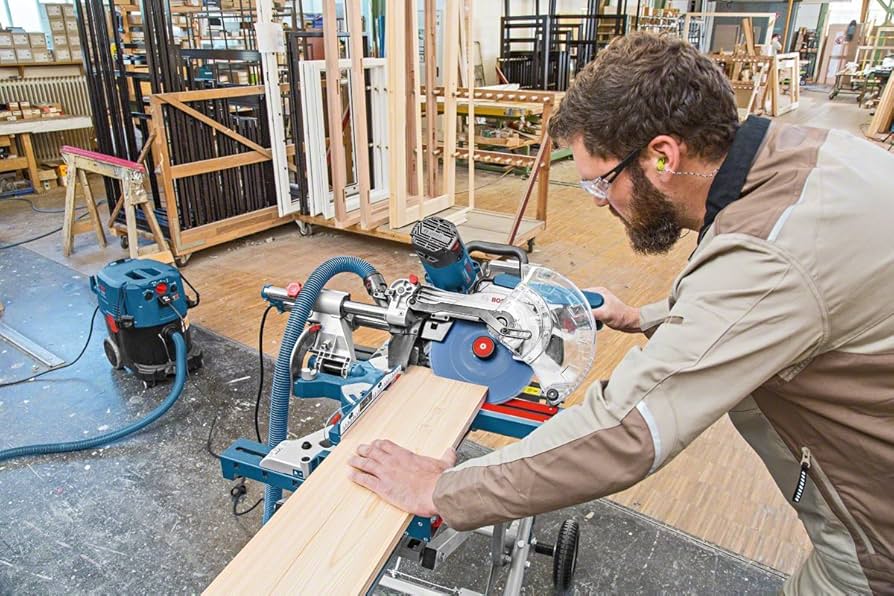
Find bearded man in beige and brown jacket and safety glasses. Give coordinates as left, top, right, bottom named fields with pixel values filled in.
left=351, top=33, right=894, bottom=594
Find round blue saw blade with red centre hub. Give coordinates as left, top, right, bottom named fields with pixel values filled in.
left=428, top=321, right=534, bottom=404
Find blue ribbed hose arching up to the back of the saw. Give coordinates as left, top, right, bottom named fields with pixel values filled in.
left=264, top=257, right=377, bottom=523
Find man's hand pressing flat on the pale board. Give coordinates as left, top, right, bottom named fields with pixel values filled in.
left=348, top=440, right=456, bottom=517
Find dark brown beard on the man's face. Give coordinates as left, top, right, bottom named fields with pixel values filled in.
left=624, top=160, right=683, bottom=255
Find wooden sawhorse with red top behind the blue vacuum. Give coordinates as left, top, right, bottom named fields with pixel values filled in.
left=61, top=145, right=174, bottom=263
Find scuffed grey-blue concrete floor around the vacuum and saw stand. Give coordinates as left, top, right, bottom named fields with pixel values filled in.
left=0, top=241, right=782, bottom=594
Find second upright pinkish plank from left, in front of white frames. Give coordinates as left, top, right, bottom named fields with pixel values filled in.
left=345, top=0, right=373, bottom=229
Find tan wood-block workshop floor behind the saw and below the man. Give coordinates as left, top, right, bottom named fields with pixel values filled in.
left=0, top=91, right=869, bottom=584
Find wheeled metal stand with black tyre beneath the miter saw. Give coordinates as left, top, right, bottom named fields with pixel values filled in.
left=369, top=517, right=580, bottom=596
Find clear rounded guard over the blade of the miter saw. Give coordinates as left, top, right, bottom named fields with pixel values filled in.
left=494, top=265, right=596, bottom=403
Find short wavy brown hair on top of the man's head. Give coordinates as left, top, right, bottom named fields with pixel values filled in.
left=549, top=32, right=739, bottom=160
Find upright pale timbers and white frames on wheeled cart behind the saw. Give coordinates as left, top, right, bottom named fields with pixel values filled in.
left=297, top=0, right=557, bottom=247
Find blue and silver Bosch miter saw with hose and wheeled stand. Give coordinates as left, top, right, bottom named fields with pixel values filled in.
left=221, top=217, right=602, bottom=594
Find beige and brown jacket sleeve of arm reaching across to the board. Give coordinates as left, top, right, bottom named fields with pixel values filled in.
left=434, top=235, right=826, bottom=530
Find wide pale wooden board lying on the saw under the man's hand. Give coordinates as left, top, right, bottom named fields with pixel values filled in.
left=204, top=367, right=486, bottom=596
